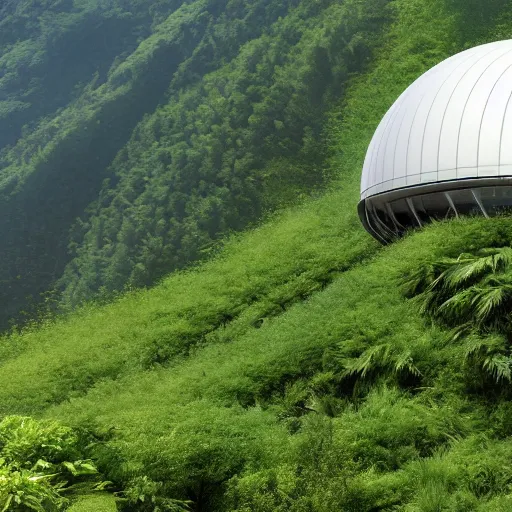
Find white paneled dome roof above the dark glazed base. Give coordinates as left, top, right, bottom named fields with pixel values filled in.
left=361, top=40, right=512, bottom=199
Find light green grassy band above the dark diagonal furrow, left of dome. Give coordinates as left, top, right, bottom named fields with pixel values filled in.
left=0, top=186, right=376, bottom=413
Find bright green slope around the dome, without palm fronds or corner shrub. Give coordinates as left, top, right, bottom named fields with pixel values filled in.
left=0, top=0, right=512, bottom=511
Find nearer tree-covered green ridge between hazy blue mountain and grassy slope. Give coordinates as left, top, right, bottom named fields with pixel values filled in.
left=60, top=0, right=387, bottom=304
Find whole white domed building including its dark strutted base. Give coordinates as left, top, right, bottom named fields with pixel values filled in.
left=358, top=40, right=512, bottom=243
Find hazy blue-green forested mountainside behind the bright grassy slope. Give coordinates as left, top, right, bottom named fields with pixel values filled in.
left=0, top=0, right=389, bottom=324
